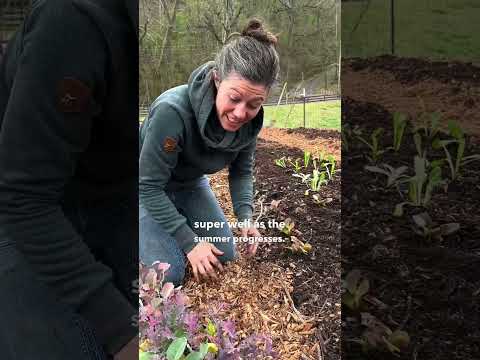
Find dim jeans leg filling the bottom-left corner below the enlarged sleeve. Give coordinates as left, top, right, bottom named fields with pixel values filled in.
left=0, top=242, right=107, bottom=360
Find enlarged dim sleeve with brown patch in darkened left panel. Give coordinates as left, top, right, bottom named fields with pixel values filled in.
left=0, top=1, right=137, bottom=353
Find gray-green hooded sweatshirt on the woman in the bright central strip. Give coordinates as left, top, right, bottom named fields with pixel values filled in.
left=139, top=62, right=263, bottom=253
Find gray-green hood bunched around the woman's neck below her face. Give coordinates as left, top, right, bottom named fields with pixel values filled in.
left=188, top=61, right=263, bottom=151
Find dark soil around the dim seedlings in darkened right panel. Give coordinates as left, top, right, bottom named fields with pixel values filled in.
left=342, top=90, right=480, bottom=360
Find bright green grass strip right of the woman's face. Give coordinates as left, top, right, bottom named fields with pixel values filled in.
left=263, top=100, right=341, bottom=130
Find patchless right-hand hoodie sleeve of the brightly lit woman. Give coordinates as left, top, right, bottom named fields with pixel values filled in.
left=228, top=139, right=257, bottom=221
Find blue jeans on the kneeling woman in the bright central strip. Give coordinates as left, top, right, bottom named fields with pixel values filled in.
left=139, top=177, right=237, bottom=286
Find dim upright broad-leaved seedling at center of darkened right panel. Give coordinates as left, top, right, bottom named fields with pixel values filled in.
left=393, top=156, right=445, bottom=217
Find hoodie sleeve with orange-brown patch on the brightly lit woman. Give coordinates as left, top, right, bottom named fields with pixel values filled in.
left=139, top=102, right=196, bottom=253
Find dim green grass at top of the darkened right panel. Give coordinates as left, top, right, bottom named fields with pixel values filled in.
left=342, top=0, right=480, bottom=62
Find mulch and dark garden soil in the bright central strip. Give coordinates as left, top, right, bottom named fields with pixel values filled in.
left=185, top=128, right=341, bottom=360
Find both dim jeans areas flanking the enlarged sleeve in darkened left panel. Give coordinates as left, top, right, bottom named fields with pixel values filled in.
left=0, top=198, right=138, bottom=360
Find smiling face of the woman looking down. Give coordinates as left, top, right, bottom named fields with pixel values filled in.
left=214, top=73, right=268, bottom=131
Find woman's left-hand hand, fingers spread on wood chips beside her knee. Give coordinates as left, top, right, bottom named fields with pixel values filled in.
left=187, top=242, right=223, bottom=282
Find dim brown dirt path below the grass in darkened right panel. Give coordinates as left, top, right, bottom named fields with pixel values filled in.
left=342, top=57, right=480, bottom=135
